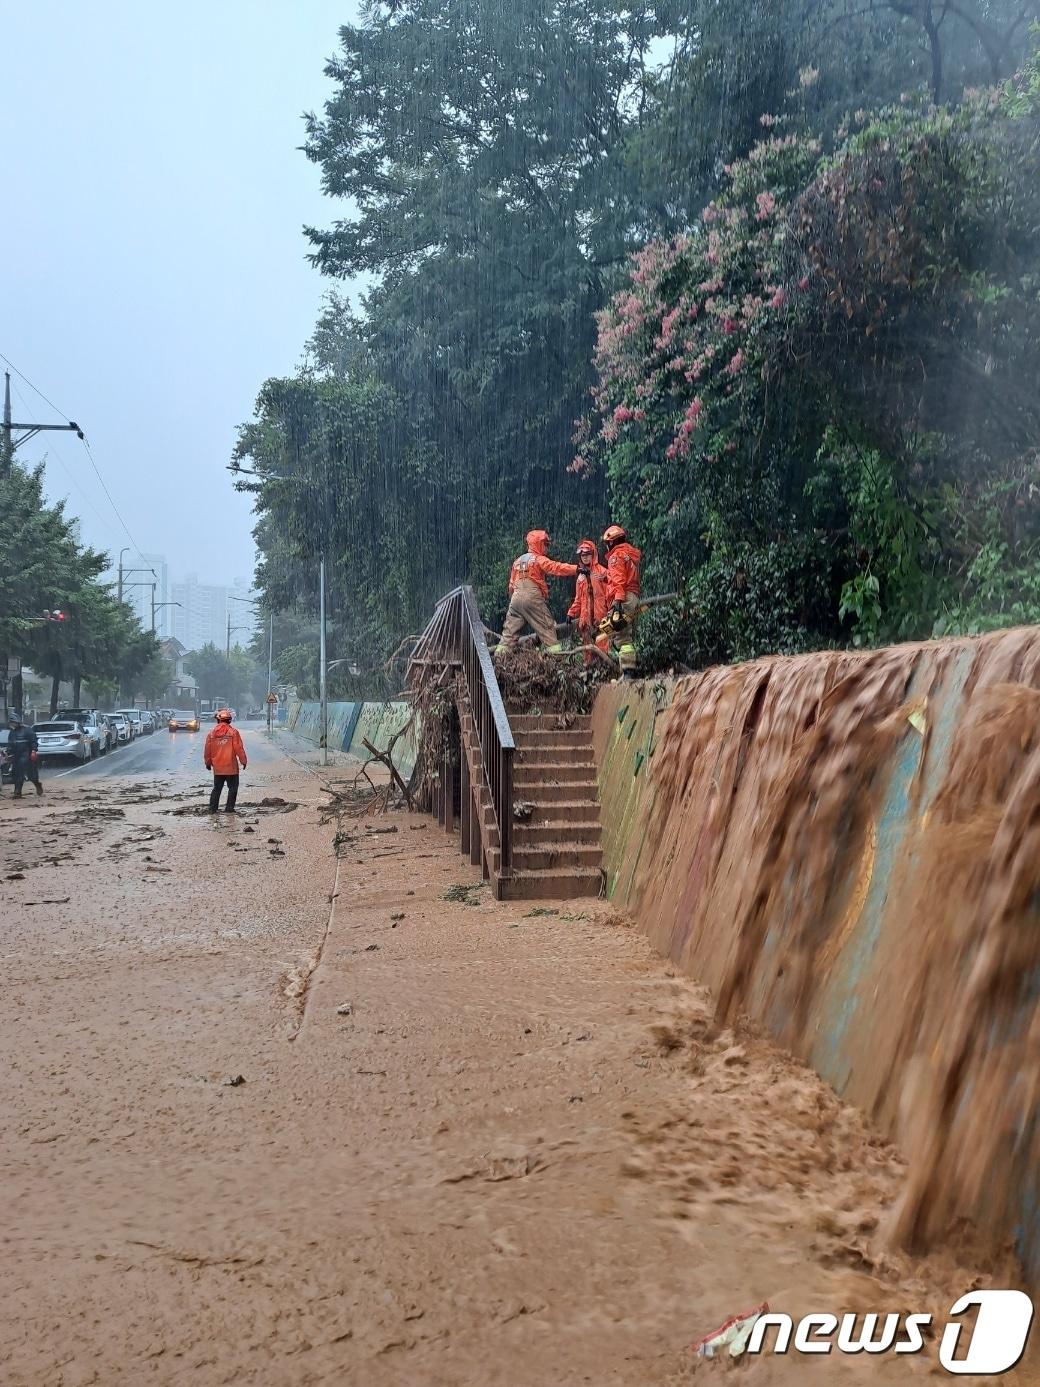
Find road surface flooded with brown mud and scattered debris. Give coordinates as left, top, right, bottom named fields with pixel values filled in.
left=0, top=734, right=1020, bottom=1387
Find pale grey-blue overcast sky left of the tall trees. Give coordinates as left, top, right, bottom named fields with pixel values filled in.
left=0, top=0, right=356, bottom=583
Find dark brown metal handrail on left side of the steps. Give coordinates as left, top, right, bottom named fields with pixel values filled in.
left=412, top=587, right=516, bottom=877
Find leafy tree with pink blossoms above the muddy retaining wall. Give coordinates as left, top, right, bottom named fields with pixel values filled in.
left=571, top=82, right=1040, bottom=662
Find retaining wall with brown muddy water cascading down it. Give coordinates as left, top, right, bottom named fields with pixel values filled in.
left=593, top=627, right=1040, bottom=1286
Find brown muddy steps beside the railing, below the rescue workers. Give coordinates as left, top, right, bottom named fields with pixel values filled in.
left=488, top=710, right=603, bottom=900
